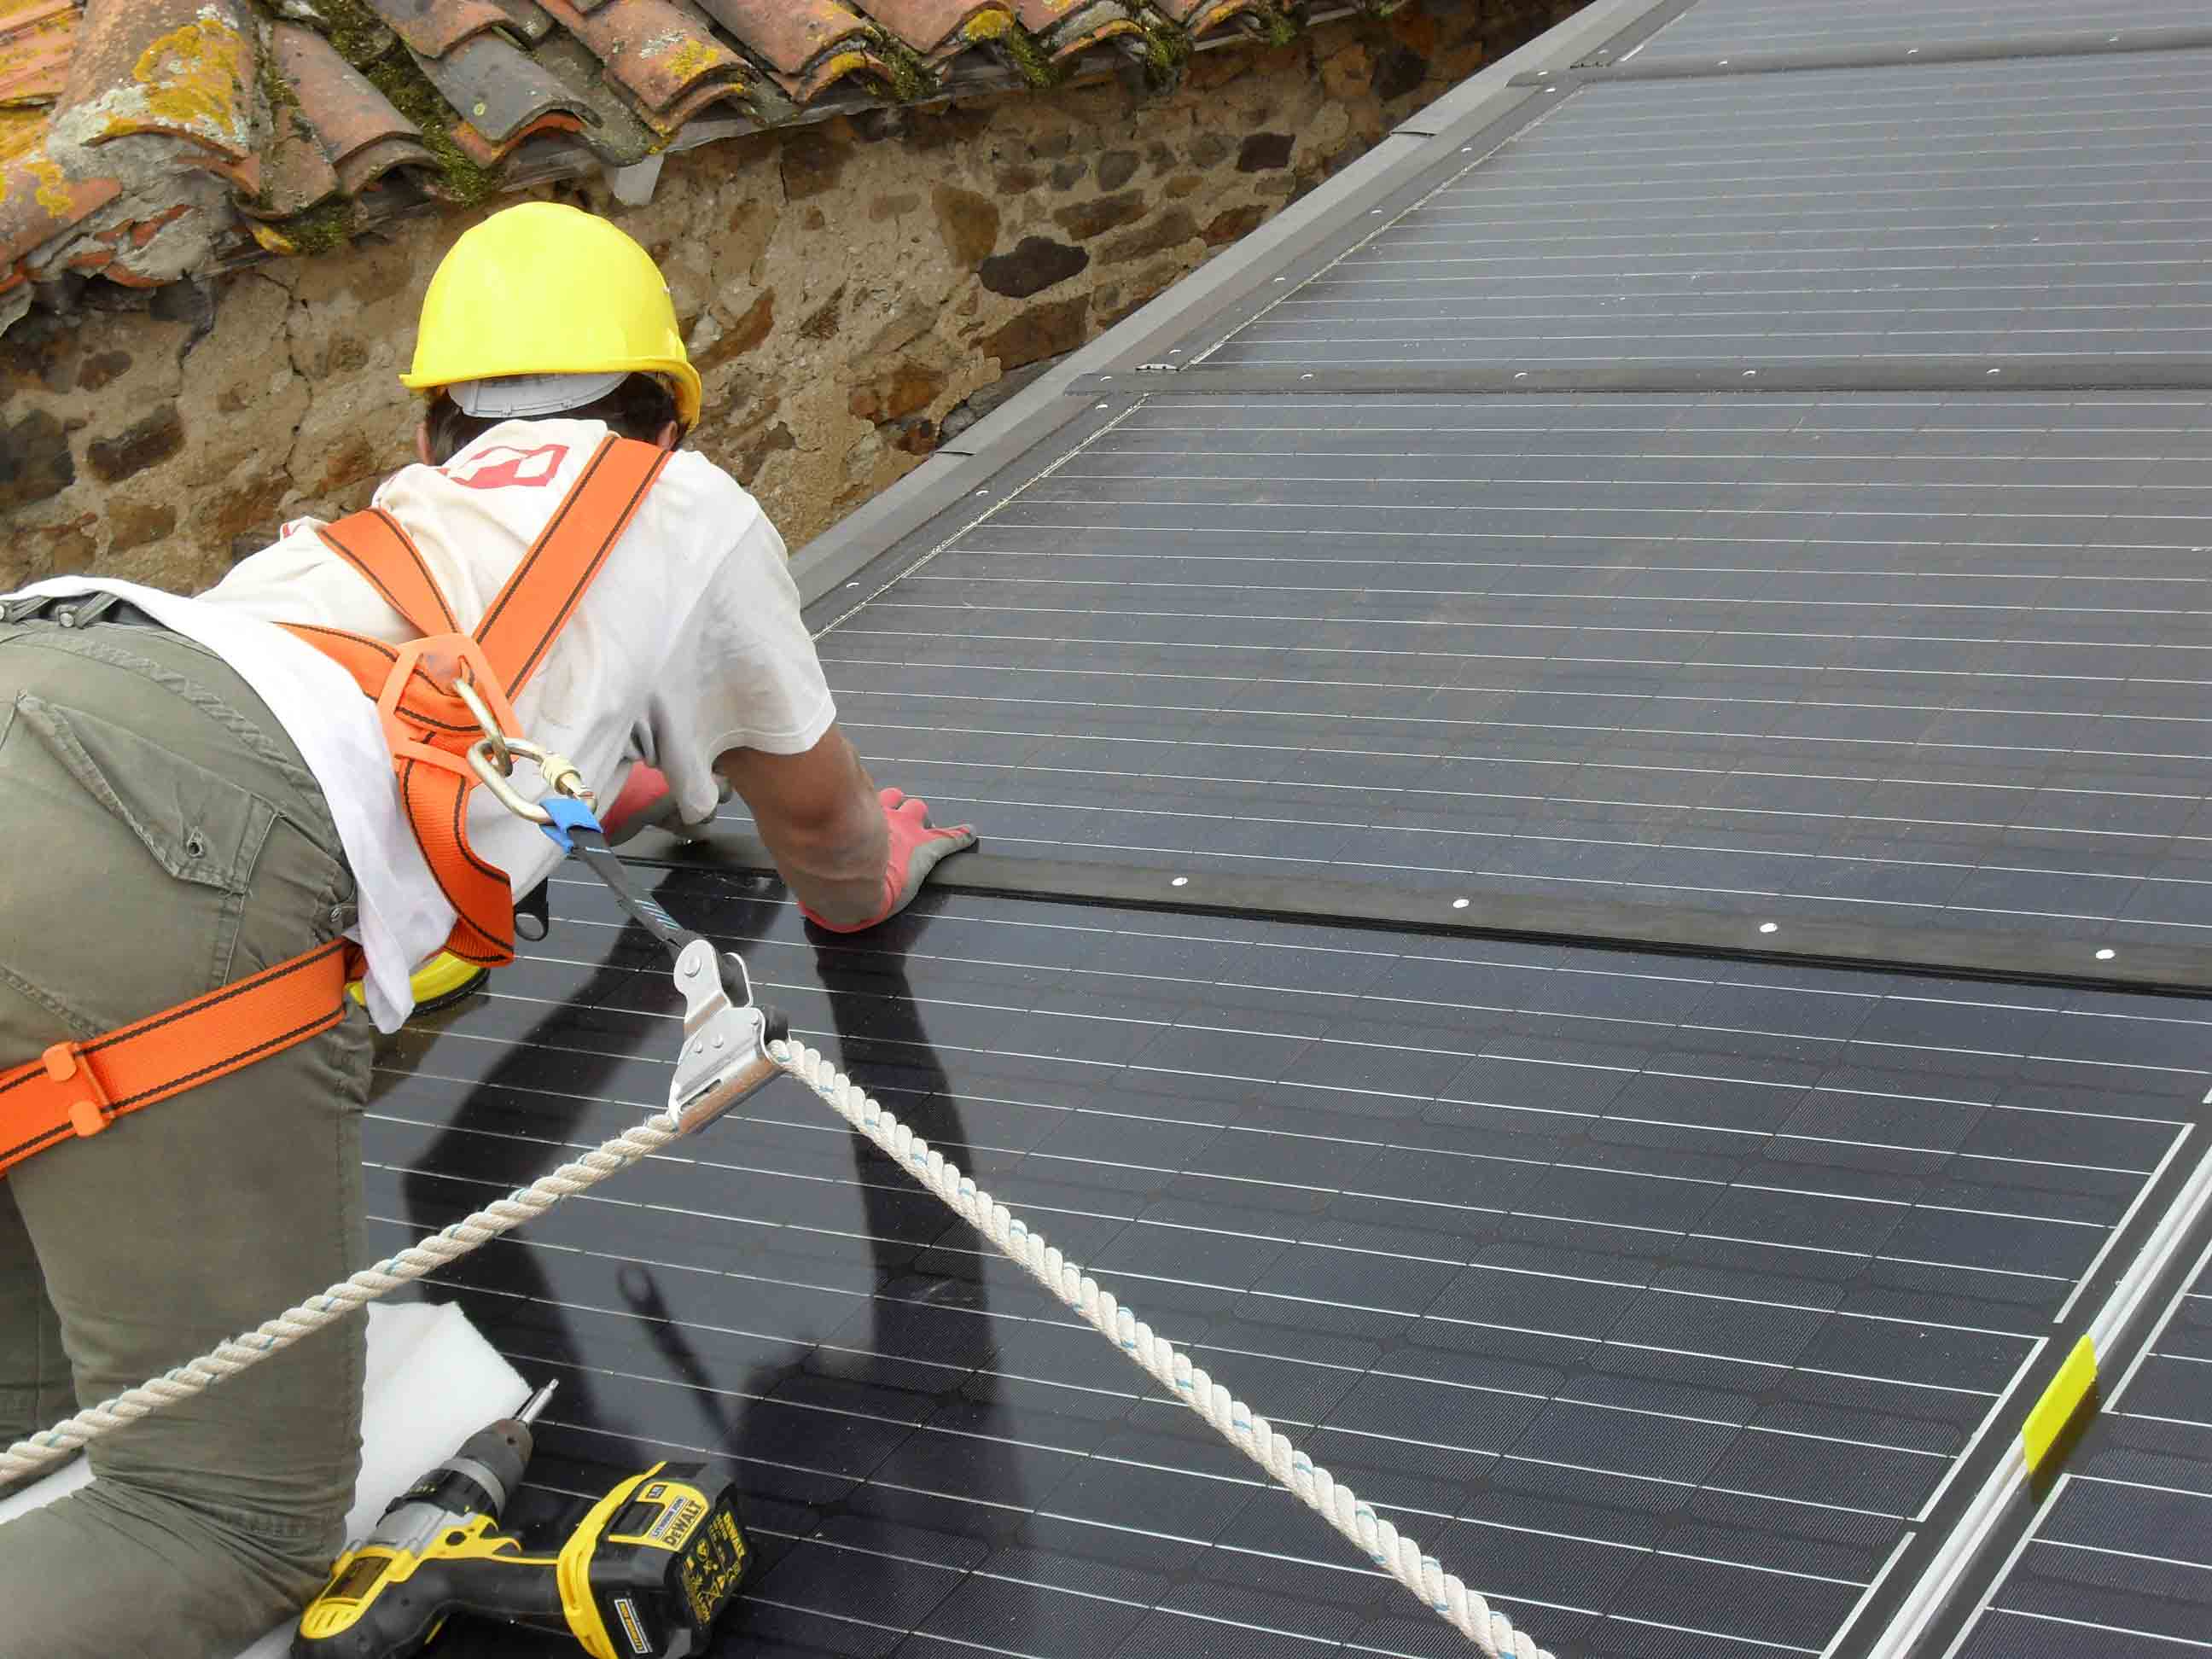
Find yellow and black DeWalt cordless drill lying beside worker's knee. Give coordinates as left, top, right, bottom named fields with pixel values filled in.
left=292, top=1382, right=748, bottom=1659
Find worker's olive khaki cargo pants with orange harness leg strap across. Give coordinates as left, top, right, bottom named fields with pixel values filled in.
left=0, top=620, right=370, bottom=1659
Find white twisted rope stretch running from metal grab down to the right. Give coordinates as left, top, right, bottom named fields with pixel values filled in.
left=770, top=1042, right=1553, bottom=1659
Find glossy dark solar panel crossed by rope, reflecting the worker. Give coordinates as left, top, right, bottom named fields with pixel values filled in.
left=367, top=874, right=2205, bottom=1659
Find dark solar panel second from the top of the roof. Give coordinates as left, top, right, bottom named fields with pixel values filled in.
left=1206, top=49, right=2212, bottom=370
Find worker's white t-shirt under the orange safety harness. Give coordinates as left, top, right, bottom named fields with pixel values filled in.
left=22, top=420, right=836, bottom=1031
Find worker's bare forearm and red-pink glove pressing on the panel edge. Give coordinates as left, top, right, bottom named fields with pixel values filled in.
left=714, top=725, right=975, bottom=934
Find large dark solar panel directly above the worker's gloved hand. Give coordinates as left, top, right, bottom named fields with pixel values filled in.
left=821, top=393, right=2212, bottom=942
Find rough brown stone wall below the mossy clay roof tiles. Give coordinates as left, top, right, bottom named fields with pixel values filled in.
left=0, top=0, right=1580, bottom=591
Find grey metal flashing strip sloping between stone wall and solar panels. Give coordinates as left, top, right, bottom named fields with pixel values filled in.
left=792, top=0, right=1681, bottom=604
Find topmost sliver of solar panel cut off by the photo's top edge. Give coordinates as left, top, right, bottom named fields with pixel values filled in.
left=1630, top=0, right=2208, bottom=62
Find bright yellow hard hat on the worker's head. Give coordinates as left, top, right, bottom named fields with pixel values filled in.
left=400, top=201, right=703, bottom=431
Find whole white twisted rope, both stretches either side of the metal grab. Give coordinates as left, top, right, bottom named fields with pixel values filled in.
left=0, top=1042, right=1553, bottom=1659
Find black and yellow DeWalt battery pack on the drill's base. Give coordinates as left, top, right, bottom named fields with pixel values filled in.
left=560, top=1462, right=750, bottom=1659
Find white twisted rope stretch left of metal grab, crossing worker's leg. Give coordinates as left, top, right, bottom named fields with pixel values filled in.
left=0, top=1113, right=677, bottom=1487
